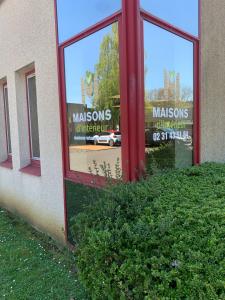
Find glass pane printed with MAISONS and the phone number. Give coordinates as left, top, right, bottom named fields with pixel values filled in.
left=144, top=22, right=193, bottom=172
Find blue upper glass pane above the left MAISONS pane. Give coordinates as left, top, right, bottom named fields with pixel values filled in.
left=57, top=0, right=121, bottom=43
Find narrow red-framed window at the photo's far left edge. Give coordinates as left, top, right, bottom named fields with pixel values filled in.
left=3, top=84, right=12, bottom=159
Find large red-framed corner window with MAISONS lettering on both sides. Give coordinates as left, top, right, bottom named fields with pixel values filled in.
left=56, top=0, right=199, bottom=185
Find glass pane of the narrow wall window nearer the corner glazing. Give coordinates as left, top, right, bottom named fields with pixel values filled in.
left=28, top=76, right=40, bottom=158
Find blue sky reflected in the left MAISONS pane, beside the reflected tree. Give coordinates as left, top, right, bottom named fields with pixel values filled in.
left=64, top=26, right=112, bottom=107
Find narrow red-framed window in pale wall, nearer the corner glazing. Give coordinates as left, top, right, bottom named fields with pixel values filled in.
left=26, top=73, right=40, bottom=162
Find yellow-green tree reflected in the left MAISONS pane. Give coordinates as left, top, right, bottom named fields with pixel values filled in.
left=82, top=23, right=120, bottom=129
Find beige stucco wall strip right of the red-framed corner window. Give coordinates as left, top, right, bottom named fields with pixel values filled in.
left=201, top=0, right=225, bottom=162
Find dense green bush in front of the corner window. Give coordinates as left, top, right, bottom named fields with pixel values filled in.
left=72, top=163, right=225, bottom=299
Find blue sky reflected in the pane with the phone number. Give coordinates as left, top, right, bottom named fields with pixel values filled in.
left=144, top=21, right=193, bottom=98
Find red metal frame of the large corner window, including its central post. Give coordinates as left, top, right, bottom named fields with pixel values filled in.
left=55, top=0, right=200, bottom=186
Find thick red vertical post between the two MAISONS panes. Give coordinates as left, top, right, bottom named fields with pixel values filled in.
left=122, top=0, right=144, bottom=180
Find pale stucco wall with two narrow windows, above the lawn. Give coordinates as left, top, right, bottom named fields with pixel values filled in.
left=0, top=0, right=64, bottom=241
